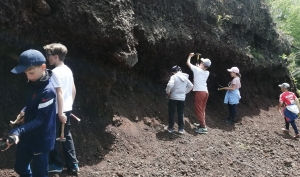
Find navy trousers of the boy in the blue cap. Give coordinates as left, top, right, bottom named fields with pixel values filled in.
left=14, top=142, right=49, bottom=177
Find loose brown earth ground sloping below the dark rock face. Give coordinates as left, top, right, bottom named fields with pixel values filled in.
left=0, top=86, right=300, bottom=177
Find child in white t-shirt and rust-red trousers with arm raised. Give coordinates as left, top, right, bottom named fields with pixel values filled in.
left=186, top=53, right=211, bottom=134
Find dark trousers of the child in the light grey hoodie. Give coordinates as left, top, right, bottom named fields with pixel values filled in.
left=168, top=99, right=185, bottom=129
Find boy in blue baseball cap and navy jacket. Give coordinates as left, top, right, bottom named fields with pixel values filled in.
left=3, top=50, right=56, bottom=177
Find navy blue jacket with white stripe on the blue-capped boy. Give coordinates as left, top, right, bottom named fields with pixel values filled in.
left=9, top=70, right=56, bottom=153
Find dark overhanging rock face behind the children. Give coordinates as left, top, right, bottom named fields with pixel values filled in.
left=0, top=0, right=290, bottom=131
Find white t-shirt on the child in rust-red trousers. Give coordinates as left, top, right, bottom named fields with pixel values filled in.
left=191, top=64, right=209, bottom=91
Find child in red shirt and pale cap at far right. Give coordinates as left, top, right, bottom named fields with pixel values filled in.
left=278, top=83, right=300, bottom=138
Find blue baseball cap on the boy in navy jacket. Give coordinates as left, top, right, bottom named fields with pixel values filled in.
left=11, top=49, right=46, bottom=74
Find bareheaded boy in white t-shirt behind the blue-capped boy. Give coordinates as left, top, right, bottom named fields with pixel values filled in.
left=44, top=43, right=79, bottom=175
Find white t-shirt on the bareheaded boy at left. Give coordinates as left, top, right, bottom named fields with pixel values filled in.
left=50, top=64, right=74, bottom=113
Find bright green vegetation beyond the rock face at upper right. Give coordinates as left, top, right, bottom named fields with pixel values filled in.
left=266, top=0, right=300, bottom=89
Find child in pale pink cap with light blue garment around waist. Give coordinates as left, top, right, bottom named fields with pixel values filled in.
left=222, top=67, right=241, bottom=124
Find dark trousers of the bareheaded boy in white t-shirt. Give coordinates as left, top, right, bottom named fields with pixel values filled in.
left=49, top=111, right=78, bottom=168
